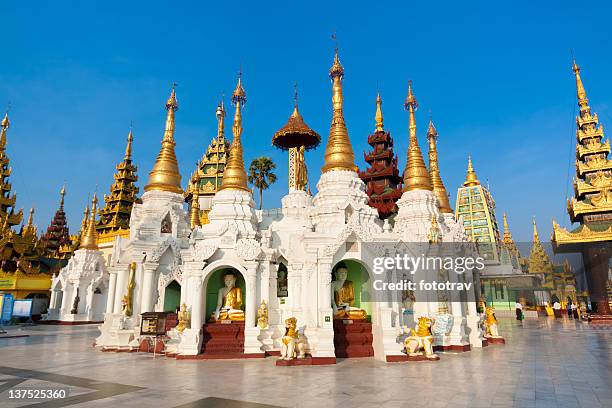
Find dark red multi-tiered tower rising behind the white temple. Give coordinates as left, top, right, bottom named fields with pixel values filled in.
left=359, top=94, right=402, bottom=219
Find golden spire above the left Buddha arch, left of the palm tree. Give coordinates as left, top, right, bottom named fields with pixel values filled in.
left=221, top=72, right=250, bottom=191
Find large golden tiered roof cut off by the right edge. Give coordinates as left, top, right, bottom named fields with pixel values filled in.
left=552, top=61, right=612, bottom=247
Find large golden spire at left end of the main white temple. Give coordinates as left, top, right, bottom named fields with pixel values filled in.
left=145, top=84, right=183, bottom=194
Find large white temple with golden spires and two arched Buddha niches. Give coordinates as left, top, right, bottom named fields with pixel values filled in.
left=92, top=52, right=483, bottom=364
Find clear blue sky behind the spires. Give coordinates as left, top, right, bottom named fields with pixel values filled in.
left=0, top=1, right=612, bottom=240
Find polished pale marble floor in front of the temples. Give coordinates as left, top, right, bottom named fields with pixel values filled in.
left=0, top=318, right=612, bottom=408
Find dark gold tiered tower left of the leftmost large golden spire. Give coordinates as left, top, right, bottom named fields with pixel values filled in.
left=96, top=129, right=138, bottom=242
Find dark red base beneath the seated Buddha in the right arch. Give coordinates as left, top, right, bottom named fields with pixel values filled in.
left=334, top=319, right=374, bottom=358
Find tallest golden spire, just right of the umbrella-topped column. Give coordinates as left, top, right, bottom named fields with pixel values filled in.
left=321, top=48, right=357, bottom=173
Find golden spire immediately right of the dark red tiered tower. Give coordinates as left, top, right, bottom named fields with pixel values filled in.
left=404, top=81, right=433, bottom=191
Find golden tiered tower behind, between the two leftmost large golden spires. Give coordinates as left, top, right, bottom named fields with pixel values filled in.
left=185, top=101, right=230, bottom=225
